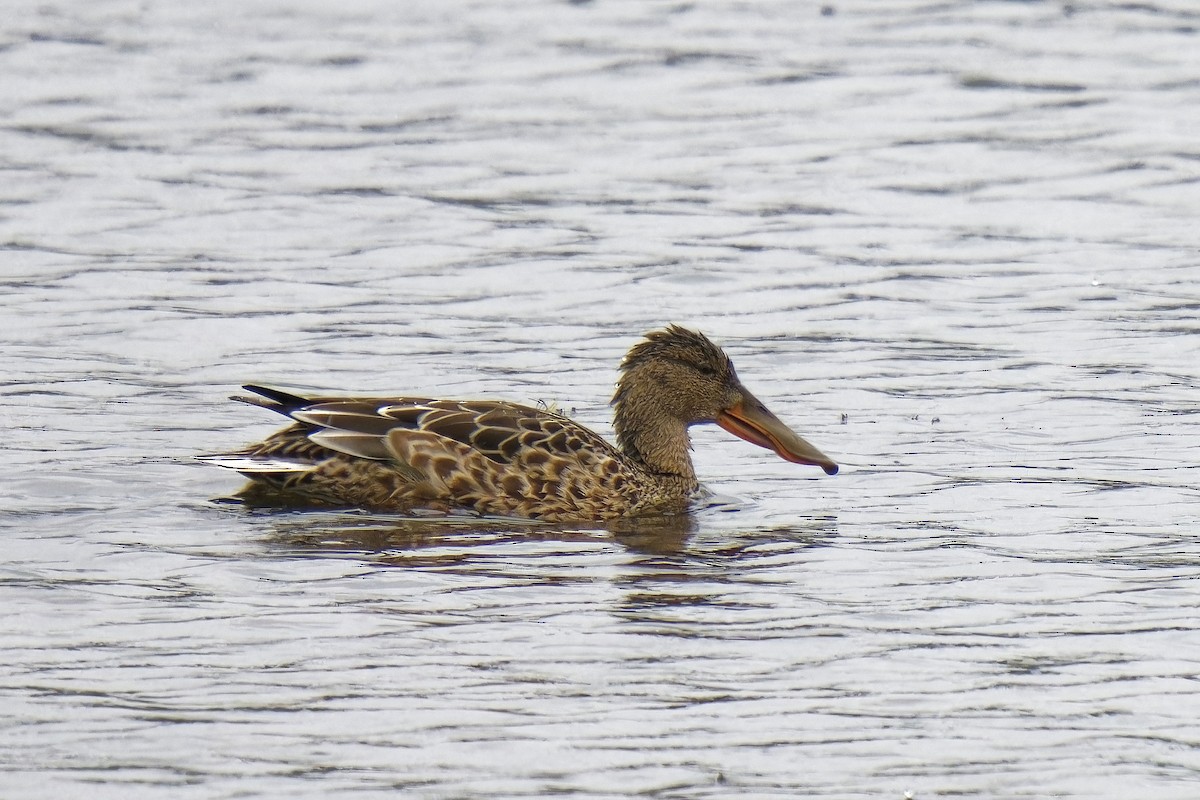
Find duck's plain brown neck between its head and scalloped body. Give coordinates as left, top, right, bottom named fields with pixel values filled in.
left=612, top=383, right=696, bottom=486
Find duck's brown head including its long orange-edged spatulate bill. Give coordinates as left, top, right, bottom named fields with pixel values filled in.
left=613, top=325, right=838, bottom=475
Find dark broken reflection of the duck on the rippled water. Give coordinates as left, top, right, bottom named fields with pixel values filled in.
left=252, top=510, right=838, bottom=619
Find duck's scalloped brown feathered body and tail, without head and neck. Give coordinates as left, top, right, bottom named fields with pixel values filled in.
left=208, top=386, right=696, bottom=522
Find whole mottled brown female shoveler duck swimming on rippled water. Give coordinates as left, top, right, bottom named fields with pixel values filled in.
left=204, top=325, right=838, bottom=522
